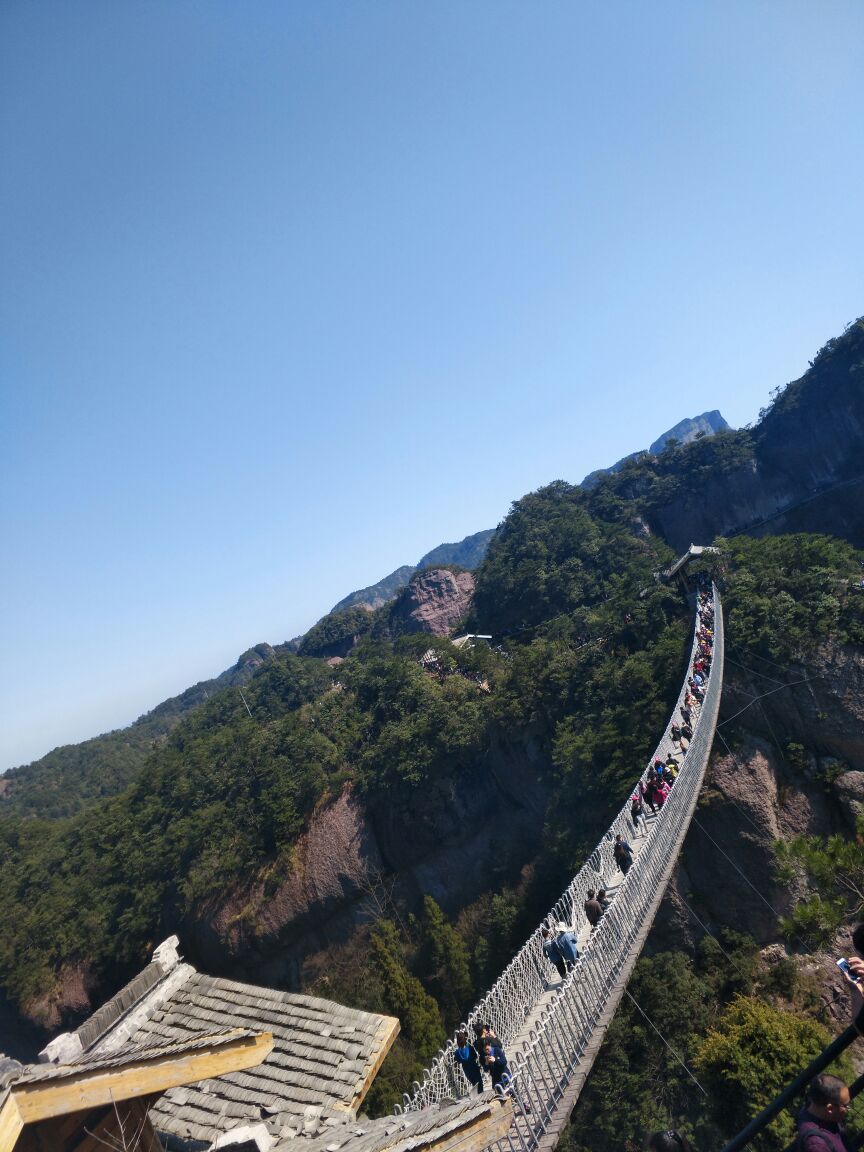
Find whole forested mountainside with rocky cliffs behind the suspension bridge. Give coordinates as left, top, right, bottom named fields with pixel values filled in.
left=0, top=321, right=864, bottom=1133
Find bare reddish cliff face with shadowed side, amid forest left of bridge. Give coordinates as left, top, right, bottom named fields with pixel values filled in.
left=190, top=741, right=548, bottom=990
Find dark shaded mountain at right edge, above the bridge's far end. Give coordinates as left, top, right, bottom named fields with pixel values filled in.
left=589, top=320, right=864, bottom=551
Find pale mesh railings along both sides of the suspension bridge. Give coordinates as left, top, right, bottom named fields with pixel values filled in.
left=397, top=588, right=723, bottom=1133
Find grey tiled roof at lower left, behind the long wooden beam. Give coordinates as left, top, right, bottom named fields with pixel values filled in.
left=67, top=962, right=399, bottom=1144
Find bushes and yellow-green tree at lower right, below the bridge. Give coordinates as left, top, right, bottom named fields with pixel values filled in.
left=560, top=931, right=855, bottom=1152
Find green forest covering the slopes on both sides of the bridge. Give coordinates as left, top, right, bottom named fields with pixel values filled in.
left=0, top=320, right=864, bottom=1152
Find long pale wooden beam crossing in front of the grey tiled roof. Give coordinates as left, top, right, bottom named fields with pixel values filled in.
left=11, top=1032, right=273, bottom=1119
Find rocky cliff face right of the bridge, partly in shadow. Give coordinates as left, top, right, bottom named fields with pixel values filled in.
left=649, top=645, right=864, bottom=1009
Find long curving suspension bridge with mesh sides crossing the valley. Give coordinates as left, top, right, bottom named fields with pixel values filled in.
left=396, top=586, right=723, bottom=1152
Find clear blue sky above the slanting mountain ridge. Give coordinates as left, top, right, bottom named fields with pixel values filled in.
left=0, top=0, right=864, bottom=770
